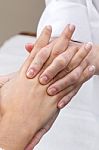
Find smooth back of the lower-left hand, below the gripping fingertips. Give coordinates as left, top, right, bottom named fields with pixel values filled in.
left=0, top=26, right=61, bottom=150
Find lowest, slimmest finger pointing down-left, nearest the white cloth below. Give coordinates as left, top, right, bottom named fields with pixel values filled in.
left=58, top=85, right=81, bottom=109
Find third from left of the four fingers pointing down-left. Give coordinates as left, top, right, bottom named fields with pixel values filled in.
left=47, top=66, right=83, bottom=96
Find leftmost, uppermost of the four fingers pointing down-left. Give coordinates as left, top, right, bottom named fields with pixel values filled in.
left=26, top=43, right=53, bottom=79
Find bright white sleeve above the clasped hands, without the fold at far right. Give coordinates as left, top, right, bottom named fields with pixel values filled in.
left=37, top=0, right=92, bottom=42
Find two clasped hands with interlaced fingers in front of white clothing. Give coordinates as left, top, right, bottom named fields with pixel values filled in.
left=0, top=25, right=95, bottom=150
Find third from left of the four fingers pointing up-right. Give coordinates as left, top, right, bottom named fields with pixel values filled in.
left=67, top=42, right=92, bottom=72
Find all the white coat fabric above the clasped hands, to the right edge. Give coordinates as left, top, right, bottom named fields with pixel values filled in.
left=38, top=0, right=99, bottom=42
